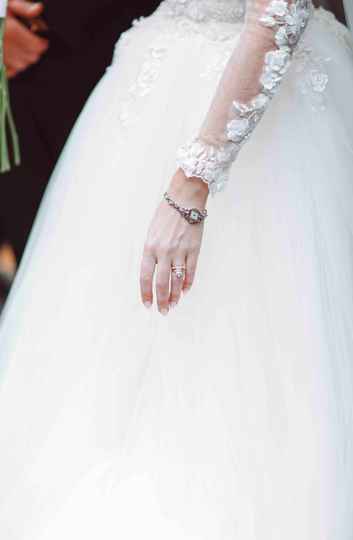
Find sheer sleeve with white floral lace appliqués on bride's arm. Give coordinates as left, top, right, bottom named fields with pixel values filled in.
left=178, top=0, right=312, bottom=193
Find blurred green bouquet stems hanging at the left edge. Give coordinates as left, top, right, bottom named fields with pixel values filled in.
left=0, top=18, right=20, bottom=173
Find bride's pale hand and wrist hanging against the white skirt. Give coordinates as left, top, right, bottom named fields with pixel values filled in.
left=140, top=170, right=208, bottom=315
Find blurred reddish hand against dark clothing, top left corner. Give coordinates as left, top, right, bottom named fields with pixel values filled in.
left=4, top=0, right=49, bottom=78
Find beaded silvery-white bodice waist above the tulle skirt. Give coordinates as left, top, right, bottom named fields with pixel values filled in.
left=162, top=0, right=246, bottom=23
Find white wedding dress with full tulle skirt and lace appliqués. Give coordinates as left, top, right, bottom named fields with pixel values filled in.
left=0, top=0, right=353, bottom=540
